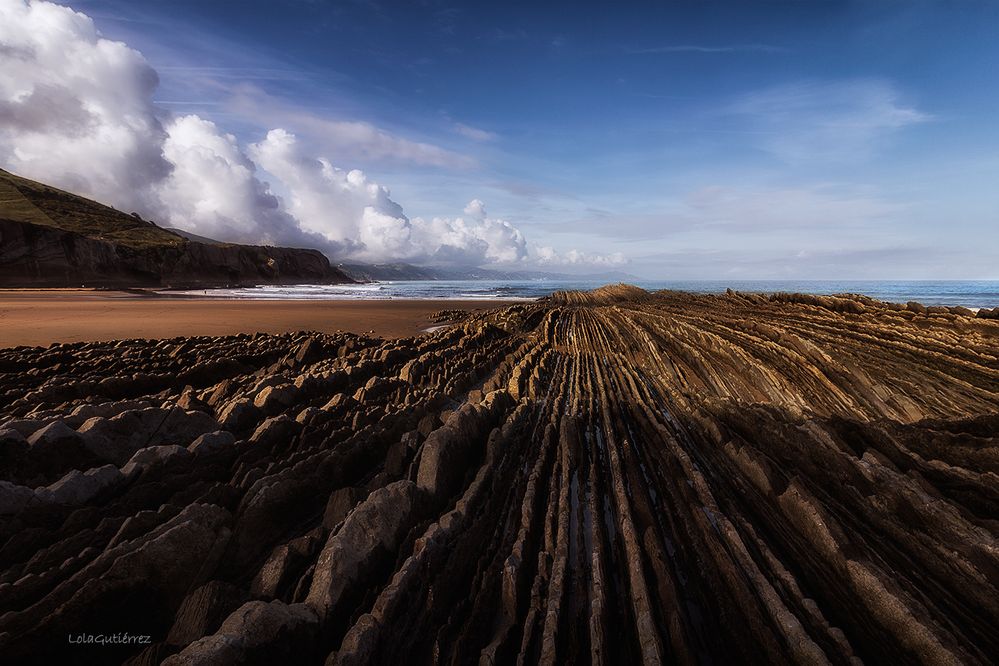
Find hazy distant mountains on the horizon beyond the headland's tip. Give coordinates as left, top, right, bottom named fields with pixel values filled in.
left=337, top=263, right=641, bottom=282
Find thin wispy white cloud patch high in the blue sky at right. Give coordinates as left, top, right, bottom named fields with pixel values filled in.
left=729, top=79, right=932, bottom=162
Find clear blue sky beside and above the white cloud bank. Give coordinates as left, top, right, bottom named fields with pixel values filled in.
left=1, top=0, right=999, bottom=279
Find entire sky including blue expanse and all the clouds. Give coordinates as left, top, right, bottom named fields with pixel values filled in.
left=0, top=0, right=999, bottom=279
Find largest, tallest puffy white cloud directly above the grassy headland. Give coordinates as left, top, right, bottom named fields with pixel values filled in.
left=0, top=0, right=170, bottom=212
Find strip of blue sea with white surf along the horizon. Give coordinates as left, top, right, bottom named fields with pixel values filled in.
left=181, top=280, right=999, bottom=308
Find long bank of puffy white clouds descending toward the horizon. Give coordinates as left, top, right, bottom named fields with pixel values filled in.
left=0, top=0, right=623, bottom=266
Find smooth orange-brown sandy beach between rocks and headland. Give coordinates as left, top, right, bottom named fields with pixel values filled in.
left=0, top=289, right=509, bottom=347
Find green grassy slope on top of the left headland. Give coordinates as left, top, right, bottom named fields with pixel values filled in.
left=0, top=169, right=188, bottom=249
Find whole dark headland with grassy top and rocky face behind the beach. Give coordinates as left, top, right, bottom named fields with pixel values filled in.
left=0, top=170, right=352, bottom=287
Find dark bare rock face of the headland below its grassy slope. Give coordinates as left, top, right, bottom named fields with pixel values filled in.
left=0, top=220, right=351, bottom=287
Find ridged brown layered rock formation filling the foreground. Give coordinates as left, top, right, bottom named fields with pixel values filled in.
left=0, top=288, right=999, bottom=665
